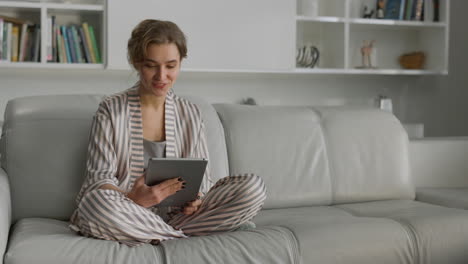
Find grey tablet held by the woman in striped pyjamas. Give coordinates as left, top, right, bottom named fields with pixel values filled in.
left=145, top=158, right=208, bottom=207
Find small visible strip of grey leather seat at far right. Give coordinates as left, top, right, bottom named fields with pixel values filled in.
left=416, top=187, right=468, bottom=209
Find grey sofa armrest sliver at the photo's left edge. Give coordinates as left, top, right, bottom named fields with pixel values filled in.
left=0, top=168, right=11, bottom=263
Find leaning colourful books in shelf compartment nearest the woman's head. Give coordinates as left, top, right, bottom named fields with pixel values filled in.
left=46, top=16, right=102, bottom=63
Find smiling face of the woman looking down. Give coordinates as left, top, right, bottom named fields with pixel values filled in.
left=138, top=43, right=180, bottom=97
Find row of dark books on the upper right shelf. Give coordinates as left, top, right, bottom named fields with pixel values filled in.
left=377, top=0, right=440, bottom=22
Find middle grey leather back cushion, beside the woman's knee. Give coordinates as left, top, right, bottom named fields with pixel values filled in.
left=214, top=104, right=331, bottom=208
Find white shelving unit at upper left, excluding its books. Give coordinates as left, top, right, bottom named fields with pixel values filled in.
left=0, top=0, right=107, bottom=69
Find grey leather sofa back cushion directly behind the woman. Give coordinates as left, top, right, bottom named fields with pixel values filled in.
left=1, top=95, right=228, bottom=221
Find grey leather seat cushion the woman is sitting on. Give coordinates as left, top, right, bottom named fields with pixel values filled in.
left=5, top=218, right=298, bottom=264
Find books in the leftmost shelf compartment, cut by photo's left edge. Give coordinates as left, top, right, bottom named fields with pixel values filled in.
left=0, top=16, right=41, bottom=62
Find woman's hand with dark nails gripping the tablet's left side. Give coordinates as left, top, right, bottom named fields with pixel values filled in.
left=127, top=175, right=185, bottom=208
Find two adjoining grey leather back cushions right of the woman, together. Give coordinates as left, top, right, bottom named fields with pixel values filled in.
left=215, top=104, right=414, bottom=208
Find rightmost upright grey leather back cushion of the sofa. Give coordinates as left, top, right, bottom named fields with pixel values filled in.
left=314, top=107, right=415, bottom=204
